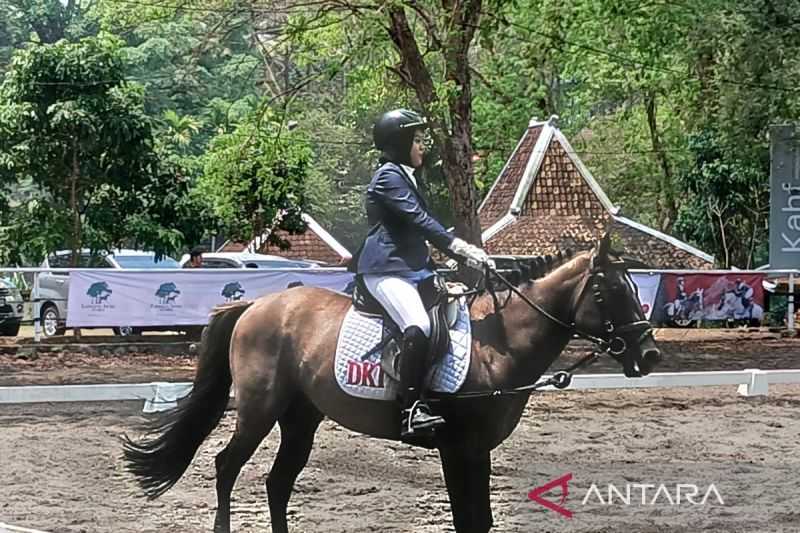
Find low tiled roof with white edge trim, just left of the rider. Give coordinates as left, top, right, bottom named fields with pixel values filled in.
left=218, top=213, right=351, bottom=265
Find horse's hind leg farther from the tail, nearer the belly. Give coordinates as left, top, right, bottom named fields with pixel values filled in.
left=266, top=395, right=323, bottom=533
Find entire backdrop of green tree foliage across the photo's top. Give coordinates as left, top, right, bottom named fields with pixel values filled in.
left=0, top=0, right=800, bottom=266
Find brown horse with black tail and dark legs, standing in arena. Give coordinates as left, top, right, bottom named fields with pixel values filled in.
left=123, top=236, right=660, bottom=533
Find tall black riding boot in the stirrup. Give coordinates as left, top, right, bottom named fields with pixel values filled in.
left=400, top=326, right=444, bottom=441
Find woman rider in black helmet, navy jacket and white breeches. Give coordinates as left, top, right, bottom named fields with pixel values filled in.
left=351, top=109, right=491, bottom=440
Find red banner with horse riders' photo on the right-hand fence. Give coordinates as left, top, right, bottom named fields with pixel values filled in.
left=653, top=272, right=765, bottom=327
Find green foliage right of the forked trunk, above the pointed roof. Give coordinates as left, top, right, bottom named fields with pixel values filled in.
left=474, top=0, right=800, bottom=266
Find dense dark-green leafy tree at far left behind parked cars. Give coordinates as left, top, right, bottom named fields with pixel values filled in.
left=0, top=35, right=206, bottom=258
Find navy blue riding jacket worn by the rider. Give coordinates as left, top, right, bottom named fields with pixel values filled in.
left=354, top=163, right=454, bottom=274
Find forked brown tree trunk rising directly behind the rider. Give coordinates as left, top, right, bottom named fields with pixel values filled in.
left=388, top=0, right=482, bottom=246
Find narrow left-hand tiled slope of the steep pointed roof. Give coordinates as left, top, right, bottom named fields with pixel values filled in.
left=478, top=125, right=542, bottom=229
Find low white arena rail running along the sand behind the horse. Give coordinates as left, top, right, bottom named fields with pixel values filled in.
left=0, top=369, right=800, bottom=412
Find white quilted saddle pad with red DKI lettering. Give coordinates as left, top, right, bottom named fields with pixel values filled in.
left=334, top=298, right=472, bottom=401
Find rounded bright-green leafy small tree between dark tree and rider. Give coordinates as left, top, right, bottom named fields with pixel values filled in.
left=198, top=107, right=311, bottom=246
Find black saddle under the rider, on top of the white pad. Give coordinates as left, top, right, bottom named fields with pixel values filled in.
left=353, top=275, right=458, bottom=378
